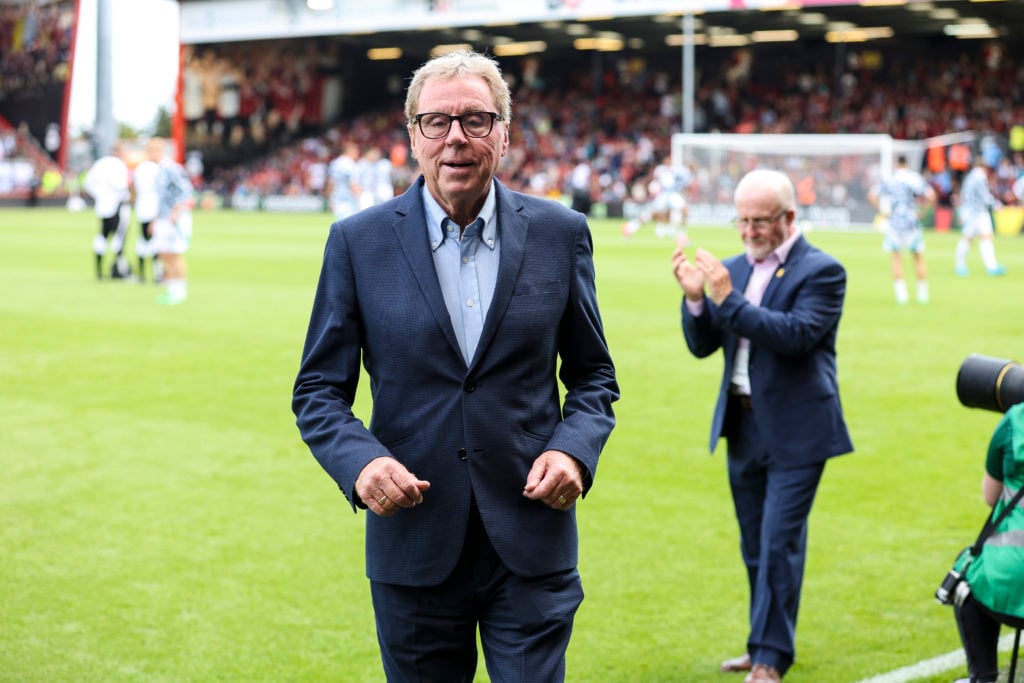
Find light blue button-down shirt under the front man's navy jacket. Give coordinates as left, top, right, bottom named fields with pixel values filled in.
left=423, top=181, right=501, bottom=366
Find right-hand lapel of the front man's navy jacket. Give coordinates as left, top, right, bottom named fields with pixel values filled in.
left=469, top=179, right=529, bottom=369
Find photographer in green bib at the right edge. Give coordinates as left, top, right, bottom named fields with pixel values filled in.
left=953, top=402, right=1024, bottom=683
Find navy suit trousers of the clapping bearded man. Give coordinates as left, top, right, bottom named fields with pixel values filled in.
left=725, top=397, right=824, bottom=674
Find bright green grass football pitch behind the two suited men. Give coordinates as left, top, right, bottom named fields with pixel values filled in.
left=0, top=209, right=1024, bottom=683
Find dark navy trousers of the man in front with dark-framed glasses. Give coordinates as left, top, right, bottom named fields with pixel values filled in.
left=371, top=505, right=583, bottom=683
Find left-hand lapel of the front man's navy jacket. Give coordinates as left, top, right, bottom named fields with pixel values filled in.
left=391, top=176, right=462, bottom=358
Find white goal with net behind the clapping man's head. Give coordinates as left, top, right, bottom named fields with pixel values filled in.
left=672, top=133, right=930, bottom=229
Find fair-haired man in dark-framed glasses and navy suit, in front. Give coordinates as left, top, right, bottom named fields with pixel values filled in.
left=293, top=51, right=618, bottom=683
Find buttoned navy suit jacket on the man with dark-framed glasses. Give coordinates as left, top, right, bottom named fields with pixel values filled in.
left=293, top=177, right=618, bottom=586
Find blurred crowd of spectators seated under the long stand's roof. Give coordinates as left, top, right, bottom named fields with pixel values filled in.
left=202, top=42, right=1024, bottom=214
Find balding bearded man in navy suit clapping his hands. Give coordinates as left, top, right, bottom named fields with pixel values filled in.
left=672, top=169, right=853, bottom=683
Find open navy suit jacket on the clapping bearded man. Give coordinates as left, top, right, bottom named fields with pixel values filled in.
left=682, top=236, right=853, bottom=466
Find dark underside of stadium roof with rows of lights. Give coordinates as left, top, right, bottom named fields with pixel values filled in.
left=179, top=0, right=1024, bottom=57
